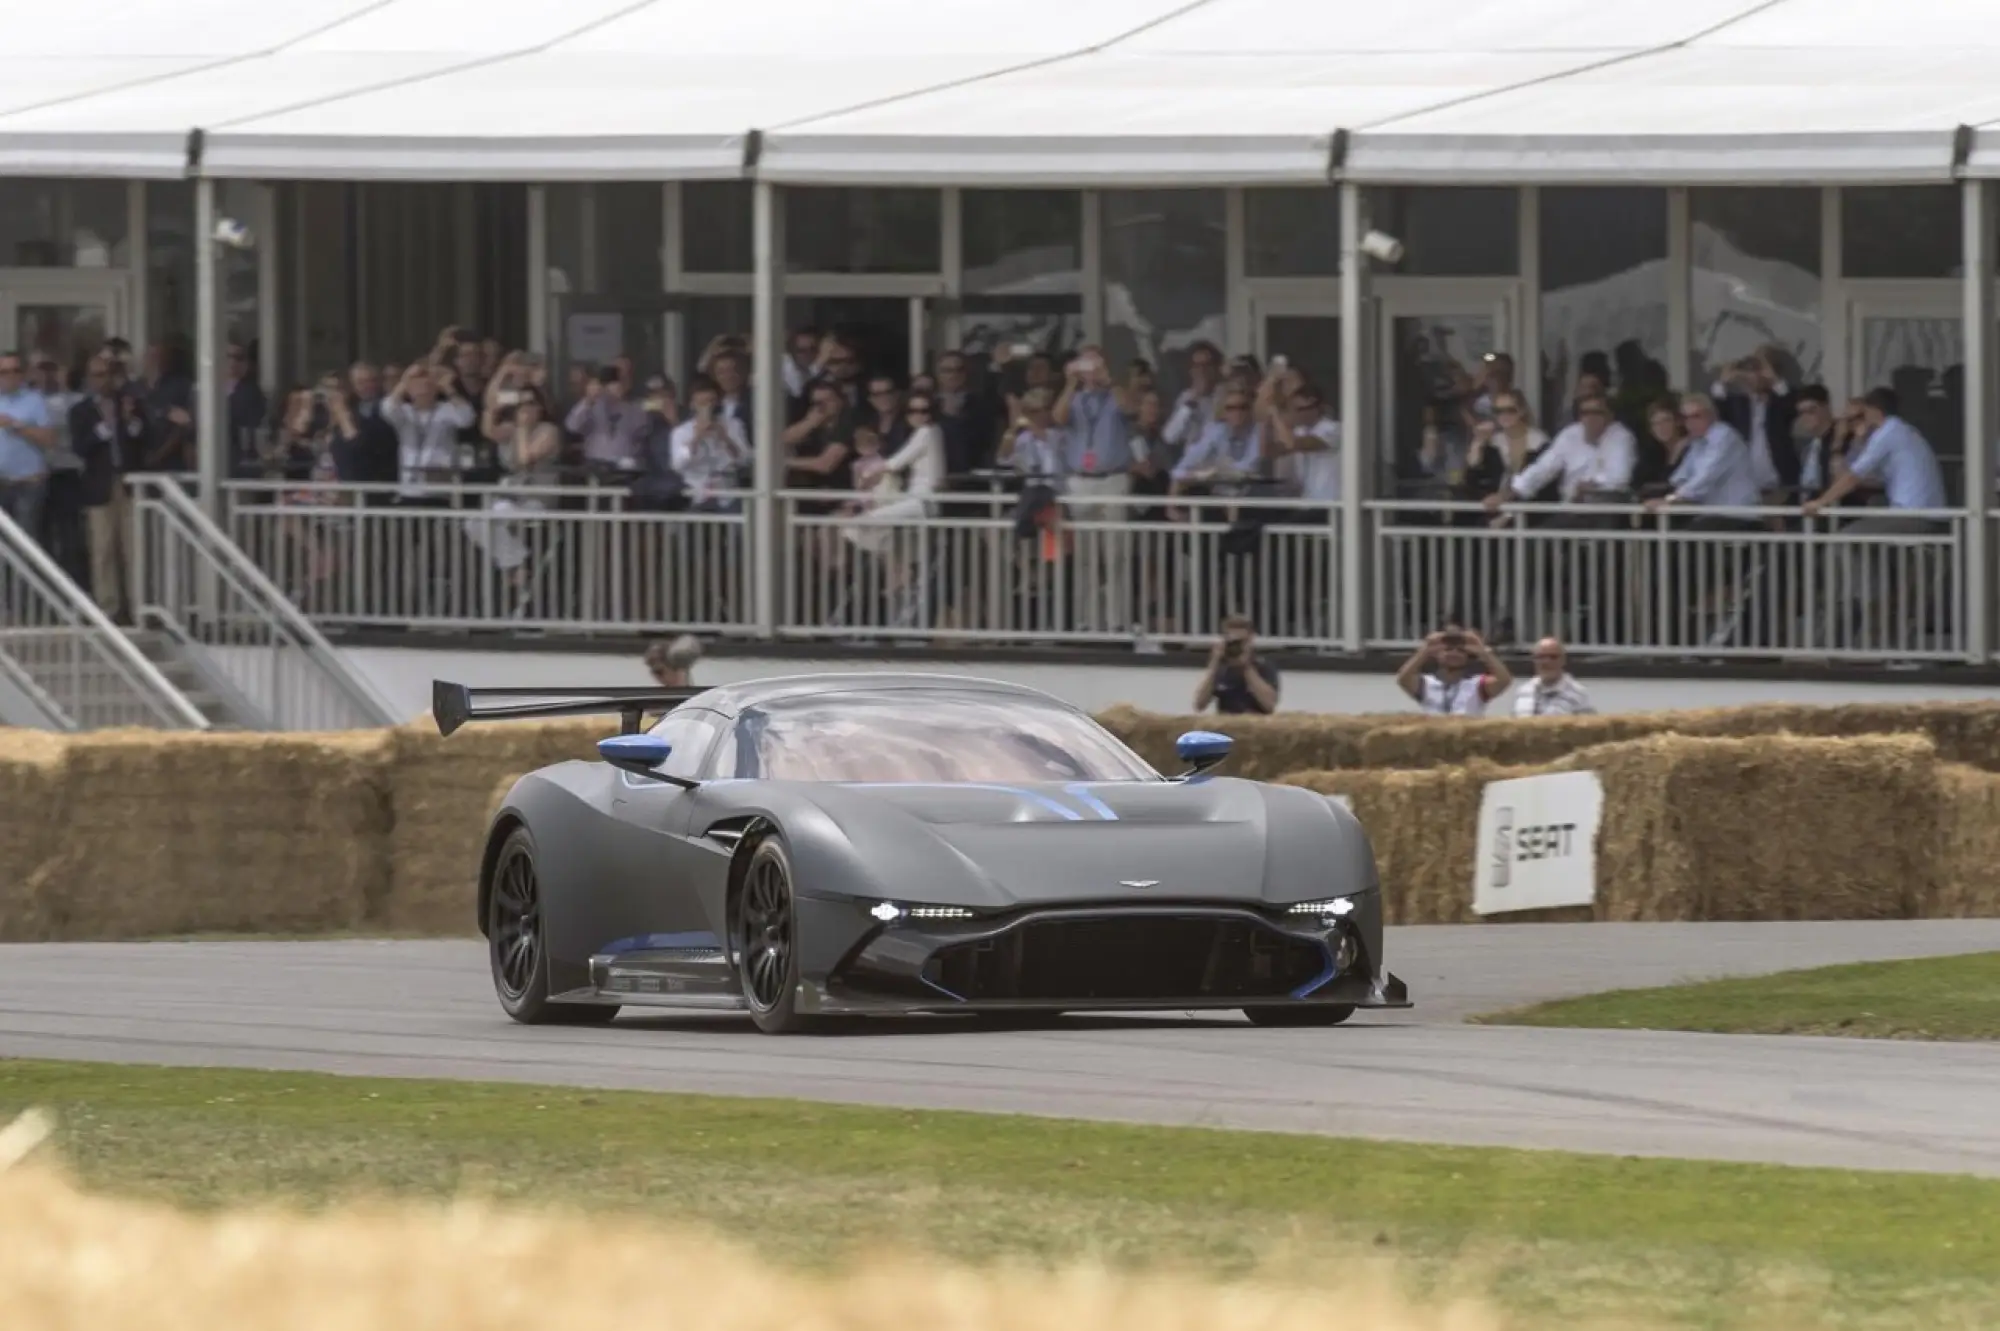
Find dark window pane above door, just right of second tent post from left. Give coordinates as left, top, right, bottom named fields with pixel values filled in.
left=782, top=186, right=944, bottom=274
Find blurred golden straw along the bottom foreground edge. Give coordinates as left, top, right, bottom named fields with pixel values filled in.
left=0, top=1159, right=1504, bottom=1331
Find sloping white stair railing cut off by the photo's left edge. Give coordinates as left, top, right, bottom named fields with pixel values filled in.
left=0, top=512, right=210, bottom=731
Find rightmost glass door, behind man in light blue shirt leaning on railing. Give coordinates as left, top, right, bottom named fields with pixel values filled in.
left=1848, top=284, right=1966, bottom=504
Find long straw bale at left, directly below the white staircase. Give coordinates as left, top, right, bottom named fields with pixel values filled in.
left=32, top=729, right=390, bottom=939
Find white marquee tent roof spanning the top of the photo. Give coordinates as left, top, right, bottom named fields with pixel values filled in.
left=11, top=0, right=2000, bottom=186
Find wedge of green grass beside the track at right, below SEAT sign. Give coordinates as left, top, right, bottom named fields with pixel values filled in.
left=1478, top=951, right=2000, bottom=1039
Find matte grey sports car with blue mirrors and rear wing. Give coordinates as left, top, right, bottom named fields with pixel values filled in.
left=432, top=673, right=1410, bottom=1033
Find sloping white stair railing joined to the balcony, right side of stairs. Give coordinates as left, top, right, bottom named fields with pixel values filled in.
left=130, top=476, right=404, bottom=729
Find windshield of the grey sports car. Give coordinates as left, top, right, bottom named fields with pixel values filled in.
left=736, top=689, right=1160, bottom=783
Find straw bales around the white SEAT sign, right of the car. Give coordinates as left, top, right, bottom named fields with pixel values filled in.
left=1286, top=735, right=1944, bottom=923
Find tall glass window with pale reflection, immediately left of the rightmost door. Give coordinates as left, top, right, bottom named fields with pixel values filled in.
left=1688, top=188, right=1826, bottom=386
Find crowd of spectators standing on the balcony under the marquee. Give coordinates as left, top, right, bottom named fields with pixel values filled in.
left=0, top=319, right=1948, bottom=651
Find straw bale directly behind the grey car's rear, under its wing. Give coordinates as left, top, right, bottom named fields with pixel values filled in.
left=386, top=717, right=618, bottom=933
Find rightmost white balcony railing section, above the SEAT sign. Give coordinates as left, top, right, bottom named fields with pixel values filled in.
left=1366, top=502, right=1970, bottom=662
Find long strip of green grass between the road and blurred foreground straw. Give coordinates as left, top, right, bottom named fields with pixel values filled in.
left=0, top=1061, right=2000, bottom=1327
